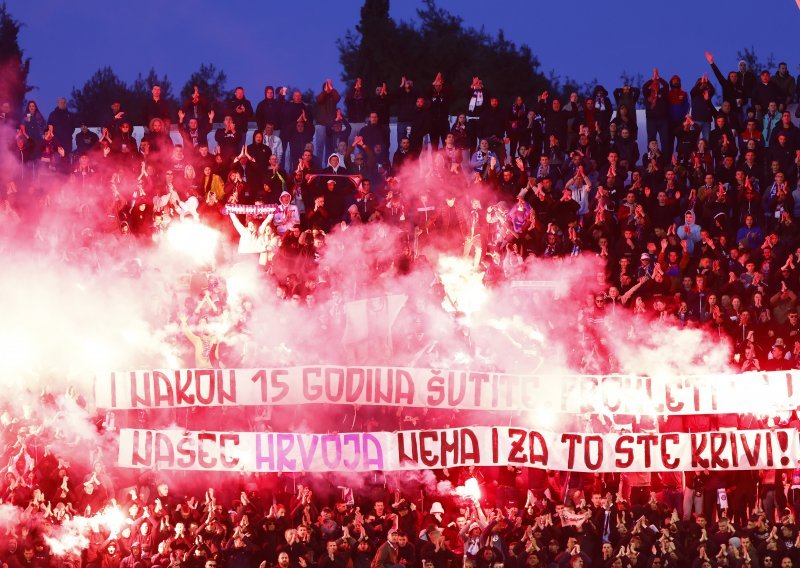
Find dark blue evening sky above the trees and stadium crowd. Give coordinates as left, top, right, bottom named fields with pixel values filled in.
left=14, top=0, right=800, bottom=110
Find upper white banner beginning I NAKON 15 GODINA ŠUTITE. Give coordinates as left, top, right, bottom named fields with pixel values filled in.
left=95, top=366, right=800, bottom=416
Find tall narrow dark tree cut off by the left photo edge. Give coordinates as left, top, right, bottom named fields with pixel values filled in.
left=0, top=2, right=32, bottom=112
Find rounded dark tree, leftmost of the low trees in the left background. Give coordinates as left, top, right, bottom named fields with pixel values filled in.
left=69, top=67, right=141, bottom=126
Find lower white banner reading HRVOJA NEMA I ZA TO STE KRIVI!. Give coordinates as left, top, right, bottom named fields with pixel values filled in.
left=119, top=426, right=800, bottom=472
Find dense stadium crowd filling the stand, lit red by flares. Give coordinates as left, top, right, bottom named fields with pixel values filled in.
left=0, top=54, right=800, bottom=568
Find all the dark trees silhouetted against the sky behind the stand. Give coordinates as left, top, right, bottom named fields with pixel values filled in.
left=0, top=0, right=776, bottom=124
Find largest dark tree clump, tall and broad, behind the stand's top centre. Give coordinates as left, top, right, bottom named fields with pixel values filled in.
left=338, top=0, right=552, bottom=111
